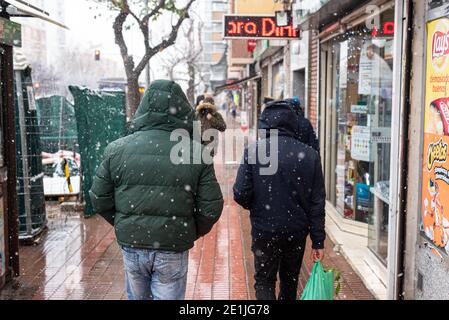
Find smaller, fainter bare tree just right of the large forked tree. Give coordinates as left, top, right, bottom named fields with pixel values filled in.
left=161, top=15, right=204, bottom=104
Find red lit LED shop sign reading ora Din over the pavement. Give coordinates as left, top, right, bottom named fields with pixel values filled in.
left=223, top=15, right=299, bottom=39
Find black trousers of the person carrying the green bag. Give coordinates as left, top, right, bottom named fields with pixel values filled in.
left=252, top=236, right=307, bottom=300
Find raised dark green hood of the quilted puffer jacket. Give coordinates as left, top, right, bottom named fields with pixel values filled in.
left=130, top=80, right=196, bottom=135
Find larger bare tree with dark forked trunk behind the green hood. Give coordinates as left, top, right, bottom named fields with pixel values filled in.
left=96, top=0, right=195, bottom=118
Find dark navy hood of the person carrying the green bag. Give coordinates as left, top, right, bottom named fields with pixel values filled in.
left=259, top=100, right=299, bottom=139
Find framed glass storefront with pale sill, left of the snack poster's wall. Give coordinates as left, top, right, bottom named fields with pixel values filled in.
left=309, top=1, right=404, bottom=299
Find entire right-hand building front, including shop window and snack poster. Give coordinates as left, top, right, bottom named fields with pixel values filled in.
left=301, top=0, right=449, bottom=299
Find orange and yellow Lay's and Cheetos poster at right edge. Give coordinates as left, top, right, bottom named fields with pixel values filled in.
left=421, top=18, right=449, bottom=254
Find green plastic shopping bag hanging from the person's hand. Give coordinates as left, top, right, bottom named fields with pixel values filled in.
left=301, top=261, right=340, bottom=300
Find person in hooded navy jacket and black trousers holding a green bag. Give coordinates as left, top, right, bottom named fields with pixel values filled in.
left=234, top=101, right=326, bottom=300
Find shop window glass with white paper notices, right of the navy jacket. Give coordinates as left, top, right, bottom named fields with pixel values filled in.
left=328, top=10, right=394, bottom=261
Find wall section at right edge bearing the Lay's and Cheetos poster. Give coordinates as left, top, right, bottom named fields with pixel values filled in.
left=404, top=0, right=449, bottom=300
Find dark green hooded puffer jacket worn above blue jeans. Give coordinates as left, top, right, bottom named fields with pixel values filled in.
left=90, top=80, right=223, bottom=252
